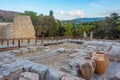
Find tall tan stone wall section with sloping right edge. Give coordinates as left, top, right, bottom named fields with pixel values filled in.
left=13, top=16, right=35, bottom=38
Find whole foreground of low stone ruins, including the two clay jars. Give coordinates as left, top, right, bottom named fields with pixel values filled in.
left=0, top=39, right=120, bottom=80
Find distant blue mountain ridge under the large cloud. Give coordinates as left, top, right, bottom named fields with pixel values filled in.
left=64, top=17, right=105, bottom=23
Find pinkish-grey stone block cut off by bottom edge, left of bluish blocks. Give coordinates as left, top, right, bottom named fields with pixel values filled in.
left=19, top=72, right=39, bottom=80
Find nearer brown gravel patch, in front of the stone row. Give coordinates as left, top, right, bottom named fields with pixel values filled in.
left=33, top=53, right=71, bottom=69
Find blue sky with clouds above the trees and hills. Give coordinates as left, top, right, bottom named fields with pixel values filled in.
left=0, top=0, right=120, bottom=20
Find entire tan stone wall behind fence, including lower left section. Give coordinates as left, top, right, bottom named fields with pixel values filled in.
left=0, top=15, right=35, bottom=38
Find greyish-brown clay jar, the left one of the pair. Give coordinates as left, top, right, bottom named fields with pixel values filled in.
left=79, top=57, right=96, bottom=80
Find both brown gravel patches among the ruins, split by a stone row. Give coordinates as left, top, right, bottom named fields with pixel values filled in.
left=17, top=42, right=80, bottom=68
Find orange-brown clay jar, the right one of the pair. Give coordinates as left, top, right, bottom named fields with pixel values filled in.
left=93, top=51, right=109, bottom=75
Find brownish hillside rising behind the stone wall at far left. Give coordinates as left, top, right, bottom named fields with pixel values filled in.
left=0, top=10, right=20, bottom=19
